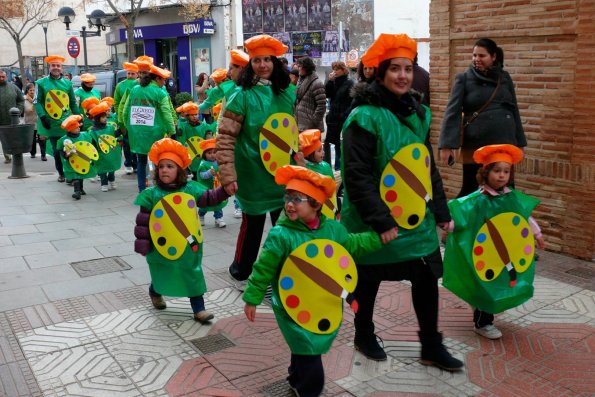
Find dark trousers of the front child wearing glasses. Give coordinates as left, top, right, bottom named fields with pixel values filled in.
left=287, top=353, right=324, bottom=397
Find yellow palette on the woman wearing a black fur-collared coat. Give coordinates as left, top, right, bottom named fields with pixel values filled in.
left=380, top=143, right=432, bottom=229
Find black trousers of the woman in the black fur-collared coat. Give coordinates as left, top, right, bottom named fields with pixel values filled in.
left=353, top=254, right=438, bottom=344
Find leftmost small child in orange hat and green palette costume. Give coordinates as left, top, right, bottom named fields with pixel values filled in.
left=56, top=114, right=98, bottom=200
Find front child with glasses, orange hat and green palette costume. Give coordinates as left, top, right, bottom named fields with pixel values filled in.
left=243, top=165, right=382, bottom=396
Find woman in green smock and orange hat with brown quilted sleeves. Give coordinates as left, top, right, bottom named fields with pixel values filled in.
left=217, top=35, right=295, bottom=281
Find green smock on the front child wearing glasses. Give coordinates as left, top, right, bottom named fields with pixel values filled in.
left=243, top=213, right=382, bottom=355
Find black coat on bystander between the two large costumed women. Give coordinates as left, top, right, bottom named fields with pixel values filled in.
left=324, top=75, right=354, bottom=145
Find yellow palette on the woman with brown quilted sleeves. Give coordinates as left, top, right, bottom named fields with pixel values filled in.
left=258, top=113, right=298, bottom=176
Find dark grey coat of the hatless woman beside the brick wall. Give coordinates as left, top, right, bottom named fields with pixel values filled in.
left=438, top=67, right=527, bottom=149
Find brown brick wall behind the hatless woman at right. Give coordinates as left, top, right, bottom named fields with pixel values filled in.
left=430, top=0, right=595, bottom=260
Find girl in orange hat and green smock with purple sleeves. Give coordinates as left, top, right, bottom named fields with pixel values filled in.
left=134, top=138, right=229, bottom=323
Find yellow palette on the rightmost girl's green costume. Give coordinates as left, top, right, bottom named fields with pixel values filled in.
left=473, top=212, right=535, bottom=287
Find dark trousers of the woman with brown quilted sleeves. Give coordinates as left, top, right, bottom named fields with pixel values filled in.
left=229, top=208, right=281, bottom=281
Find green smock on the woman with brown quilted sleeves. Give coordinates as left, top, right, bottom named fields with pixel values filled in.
left=225, top=85, right=295, bottom=215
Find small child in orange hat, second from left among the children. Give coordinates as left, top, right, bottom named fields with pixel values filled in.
left=87, top=100, right=122, bottom=192
